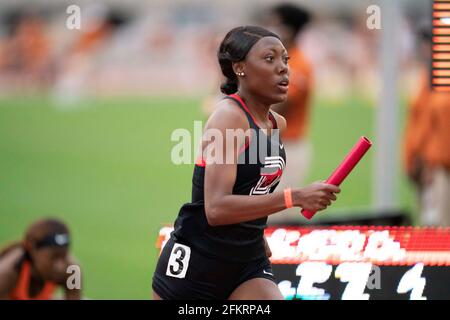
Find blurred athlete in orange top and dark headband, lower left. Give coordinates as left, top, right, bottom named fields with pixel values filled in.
left=0, top=219, right=81, bottom=300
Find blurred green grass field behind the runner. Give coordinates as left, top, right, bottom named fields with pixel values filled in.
left=0, top=97, right=414, bottom=299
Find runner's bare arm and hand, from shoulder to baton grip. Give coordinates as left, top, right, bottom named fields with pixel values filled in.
left=202, top=100, right=340, bottom=226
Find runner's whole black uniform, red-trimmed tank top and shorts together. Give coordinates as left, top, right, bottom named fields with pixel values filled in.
left=152, top=94, right=286, bottom=300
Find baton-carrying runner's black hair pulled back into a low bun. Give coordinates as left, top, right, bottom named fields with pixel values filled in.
left=217, top=26, right=280, bottom=94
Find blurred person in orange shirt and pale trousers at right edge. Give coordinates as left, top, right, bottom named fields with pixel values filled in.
left=403, top=28, right=450, bottom=226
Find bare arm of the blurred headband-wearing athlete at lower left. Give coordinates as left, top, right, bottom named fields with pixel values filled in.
left=0, top=248, right=23, bottom=300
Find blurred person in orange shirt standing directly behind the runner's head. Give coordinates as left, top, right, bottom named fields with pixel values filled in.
left=265, top=4, right=313, bottom=223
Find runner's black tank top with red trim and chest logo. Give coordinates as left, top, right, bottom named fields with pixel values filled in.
left=172, top=94, right=286, bottom=261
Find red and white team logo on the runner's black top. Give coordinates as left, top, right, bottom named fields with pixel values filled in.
left=250, top=156, right=286, bottom=195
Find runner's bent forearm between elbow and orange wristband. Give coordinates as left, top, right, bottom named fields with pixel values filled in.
left=205, top=191, right=286, bottom=226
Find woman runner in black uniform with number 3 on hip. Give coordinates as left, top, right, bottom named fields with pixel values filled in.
left=152, top=26, right=340, bottom=299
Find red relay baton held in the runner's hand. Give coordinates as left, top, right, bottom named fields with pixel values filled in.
left=301, top=137, right=372, bottom=219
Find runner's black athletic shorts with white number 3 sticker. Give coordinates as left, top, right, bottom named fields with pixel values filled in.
left=152, top=238, right=276, bottom=300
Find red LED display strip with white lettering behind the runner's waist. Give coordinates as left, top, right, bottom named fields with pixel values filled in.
left=157, top=226, right=450, bottom=266
